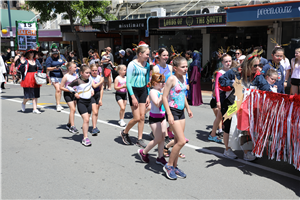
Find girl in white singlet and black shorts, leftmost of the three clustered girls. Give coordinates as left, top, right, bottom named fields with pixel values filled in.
left=60, top=62, right=78, bottom=133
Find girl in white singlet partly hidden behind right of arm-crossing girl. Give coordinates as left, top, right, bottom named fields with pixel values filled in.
left=91, top=64, right=104, bottom=136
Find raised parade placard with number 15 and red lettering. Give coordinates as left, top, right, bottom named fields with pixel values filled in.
left=16, top=21, right=38, bottom=50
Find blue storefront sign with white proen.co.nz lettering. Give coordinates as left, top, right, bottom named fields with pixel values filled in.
left=226, top=1, right=300, bottom=22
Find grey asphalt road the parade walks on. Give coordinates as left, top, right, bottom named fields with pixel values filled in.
left=0, top=84, right=300, bottom=199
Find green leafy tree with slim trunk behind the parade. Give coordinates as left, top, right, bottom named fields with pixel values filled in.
left=24, top=0, right=116, bottom=61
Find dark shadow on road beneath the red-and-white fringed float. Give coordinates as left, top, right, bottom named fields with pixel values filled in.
left=196, top=147, right=300, bottom=197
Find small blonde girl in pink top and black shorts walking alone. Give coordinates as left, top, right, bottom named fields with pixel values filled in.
left=114, top=65, right=127, bottom=127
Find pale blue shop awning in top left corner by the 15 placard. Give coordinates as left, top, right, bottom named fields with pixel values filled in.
left=0, top=9, right=36, bottom=29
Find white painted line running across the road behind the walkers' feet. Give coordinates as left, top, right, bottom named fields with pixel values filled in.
left=0, top=97, right=299, bottom=181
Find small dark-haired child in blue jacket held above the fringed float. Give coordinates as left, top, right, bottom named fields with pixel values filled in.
left=261, top=47, right=288, bottom=94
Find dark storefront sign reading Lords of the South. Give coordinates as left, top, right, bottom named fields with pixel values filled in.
left=159, top=13, right=226, bottom=28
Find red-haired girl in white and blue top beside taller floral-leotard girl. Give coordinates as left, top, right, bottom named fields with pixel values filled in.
left=138, top=73, right=167, bottom=166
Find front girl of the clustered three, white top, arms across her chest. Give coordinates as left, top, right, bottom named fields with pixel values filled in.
left=67, top=65, right=94, bottom=146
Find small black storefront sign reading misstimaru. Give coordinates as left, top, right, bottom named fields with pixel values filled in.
left=108, top=19, right=147, bottom=30
